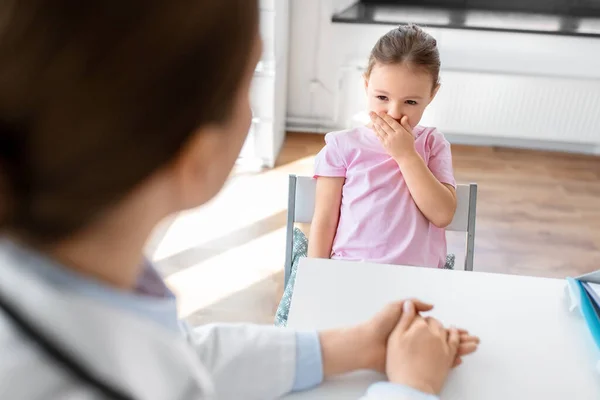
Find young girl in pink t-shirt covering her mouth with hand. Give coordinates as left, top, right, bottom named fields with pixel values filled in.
left=276, top=25, right=456, bottom=325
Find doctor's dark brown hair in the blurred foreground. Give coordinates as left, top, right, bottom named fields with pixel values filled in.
left=0, top=0, right=258, bottom=243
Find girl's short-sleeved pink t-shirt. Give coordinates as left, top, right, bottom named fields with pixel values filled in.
left=314, top=126, right=456, bottom=268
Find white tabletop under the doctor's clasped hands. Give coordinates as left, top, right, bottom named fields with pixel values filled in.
left=286, top=259, right=600, bottom=400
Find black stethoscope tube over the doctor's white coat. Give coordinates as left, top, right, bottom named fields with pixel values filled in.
left=0, top=295, right=134, bottom=400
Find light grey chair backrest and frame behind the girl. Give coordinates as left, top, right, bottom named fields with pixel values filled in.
left=285, top=175, right=477, bottom=284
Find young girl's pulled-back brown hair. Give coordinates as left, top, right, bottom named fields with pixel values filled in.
left=365, top=24, right=440, bottom=87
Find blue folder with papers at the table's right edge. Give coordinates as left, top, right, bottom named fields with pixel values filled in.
left=567, top=270, right=600, bottom=350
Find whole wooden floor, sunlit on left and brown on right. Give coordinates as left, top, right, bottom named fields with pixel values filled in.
left=150, top=133, right=600, bottom=324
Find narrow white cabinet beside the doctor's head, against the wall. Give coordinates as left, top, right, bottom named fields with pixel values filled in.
left=238, top=0, right=289, bottom=167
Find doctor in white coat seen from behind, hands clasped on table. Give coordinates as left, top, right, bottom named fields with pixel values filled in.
left=0, top=0, right=478, bottom=400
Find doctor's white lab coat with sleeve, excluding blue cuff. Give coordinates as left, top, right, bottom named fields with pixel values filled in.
left=0, top=245, right=296, bottom=400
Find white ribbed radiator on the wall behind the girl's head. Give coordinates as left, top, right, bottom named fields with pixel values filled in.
left=338, top=70, right=600, bottom=144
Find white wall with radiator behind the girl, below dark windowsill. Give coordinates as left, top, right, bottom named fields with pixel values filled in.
left=287, top=0, right=600, bottom=152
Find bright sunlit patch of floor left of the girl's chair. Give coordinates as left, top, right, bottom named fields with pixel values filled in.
left=147, top=156, right=314, bottom=322
